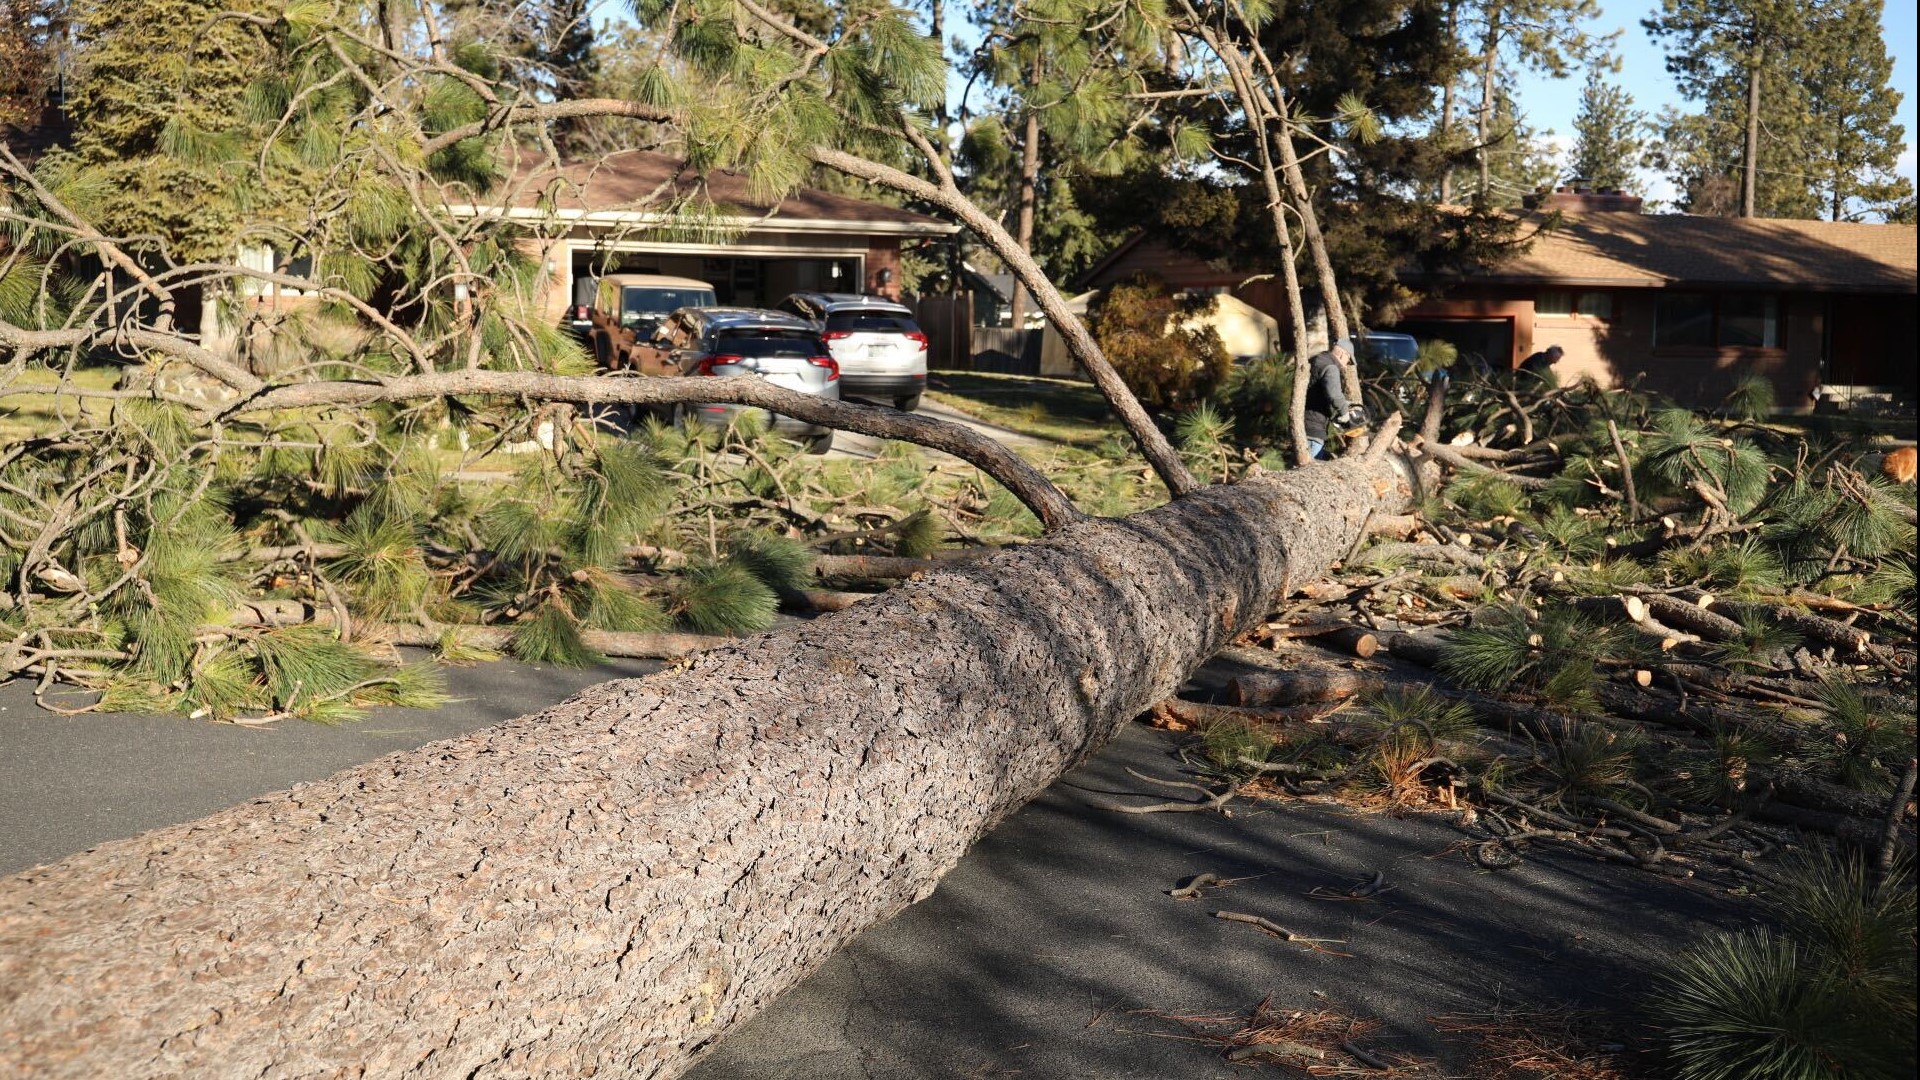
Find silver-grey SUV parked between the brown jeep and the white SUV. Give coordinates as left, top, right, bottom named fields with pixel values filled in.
left=647, top=307, right=841, bottom=454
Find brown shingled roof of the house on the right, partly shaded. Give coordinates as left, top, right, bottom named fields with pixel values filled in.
left=1471, top=213, right=1914, bottom=294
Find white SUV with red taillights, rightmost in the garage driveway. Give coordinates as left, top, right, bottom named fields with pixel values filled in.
left=778, top=292, right=927, bottom=413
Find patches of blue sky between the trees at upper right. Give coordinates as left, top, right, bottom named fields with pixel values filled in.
left=1515, top=0, right=1916, bottom=198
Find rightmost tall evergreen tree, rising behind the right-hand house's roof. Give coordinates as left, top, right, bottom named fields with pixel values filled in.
left=1801, top=0, right=1912, bottom=221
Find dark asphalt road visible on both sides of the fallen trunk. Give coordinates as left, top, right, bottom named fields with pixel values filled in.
left=0, top=645, right=1751, bottom=1080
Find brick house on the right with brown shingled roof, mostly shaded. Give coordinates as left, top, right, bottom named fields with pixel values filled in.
left=1394, top=192, right=1916, bottom=407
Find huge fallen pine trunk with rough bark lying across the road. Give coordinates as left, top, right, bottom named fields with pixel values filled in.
left=0, top=457, right=1407, bottom=1078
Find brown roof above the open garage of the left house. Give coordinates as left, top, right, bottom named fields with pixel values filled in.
left=455, top=150, right=958, bottom=236
